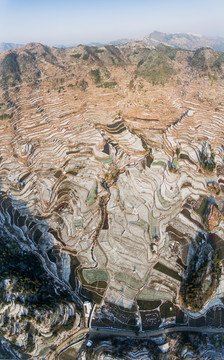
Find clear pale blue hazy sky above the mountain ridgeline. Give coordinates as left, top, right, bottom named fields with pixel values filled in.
left=0, top=0, right=224, bottom=45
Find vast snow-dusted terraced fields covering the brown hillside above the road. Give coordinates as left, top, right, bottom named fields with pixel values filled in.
left=0, top=44, right=224, bottom=356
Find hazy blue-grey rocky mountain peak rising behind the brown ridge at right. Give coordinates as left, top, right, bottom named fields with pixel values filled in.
left=143, top=31, right=224, bottom=51
